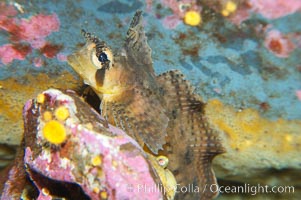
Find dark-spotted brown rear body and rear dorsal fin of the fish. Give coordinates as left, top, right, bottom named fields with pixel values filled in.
left=158, top=71, right=224, bottom=199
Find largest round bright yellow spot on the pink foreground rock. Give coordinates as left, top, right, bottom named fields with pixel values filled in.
left=43, top=120, right=67, bottom=145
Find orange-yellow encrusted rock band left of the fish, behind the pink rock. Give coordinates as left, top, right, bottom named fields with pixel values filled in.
left=0, top=71, right=80, bottom=170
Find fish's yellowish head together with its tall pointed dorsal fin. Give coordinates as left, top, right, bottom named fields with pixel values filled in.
left=68, top=11, right=157, bottom=101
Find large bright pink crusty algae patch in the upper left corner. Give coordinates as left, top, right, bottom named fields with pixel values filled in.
left=0, top=3, right=60, bottom=64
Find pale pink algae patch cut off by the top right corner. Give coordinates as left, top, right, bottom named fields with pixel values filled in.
left=249, top=0, right=301, bottom=19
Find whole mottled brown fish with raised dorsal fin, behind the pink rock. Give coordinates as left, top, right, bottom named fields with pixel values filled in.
left=68, top=11, right=224, bottom=199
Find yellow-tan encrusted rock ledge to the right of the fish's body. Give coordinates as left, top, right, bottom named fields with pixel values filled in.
left=205, top=99, right=301, bottom=185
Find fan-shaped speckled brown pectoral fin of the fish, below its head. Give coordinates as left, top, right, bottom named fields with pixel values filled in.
left=101, top=86, right=169, bottom=154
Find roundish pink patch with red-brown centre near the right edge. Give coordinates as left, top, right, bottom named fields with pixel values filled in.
left=264, top=30, right=296, bottom=58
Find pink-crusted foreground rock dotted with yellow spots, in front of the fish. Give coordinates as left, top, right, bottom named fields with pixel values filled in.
left=0, top=89, right=164, bottom=200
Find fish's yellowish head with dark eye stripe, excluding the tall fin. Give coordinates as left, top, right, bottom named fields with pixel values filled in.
left=68, top=30, right=133, bottom=100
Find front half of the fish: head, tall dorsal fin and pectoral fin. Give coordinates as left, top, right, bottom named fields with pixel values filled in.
left=68, top=12, right=168, bottom=153
